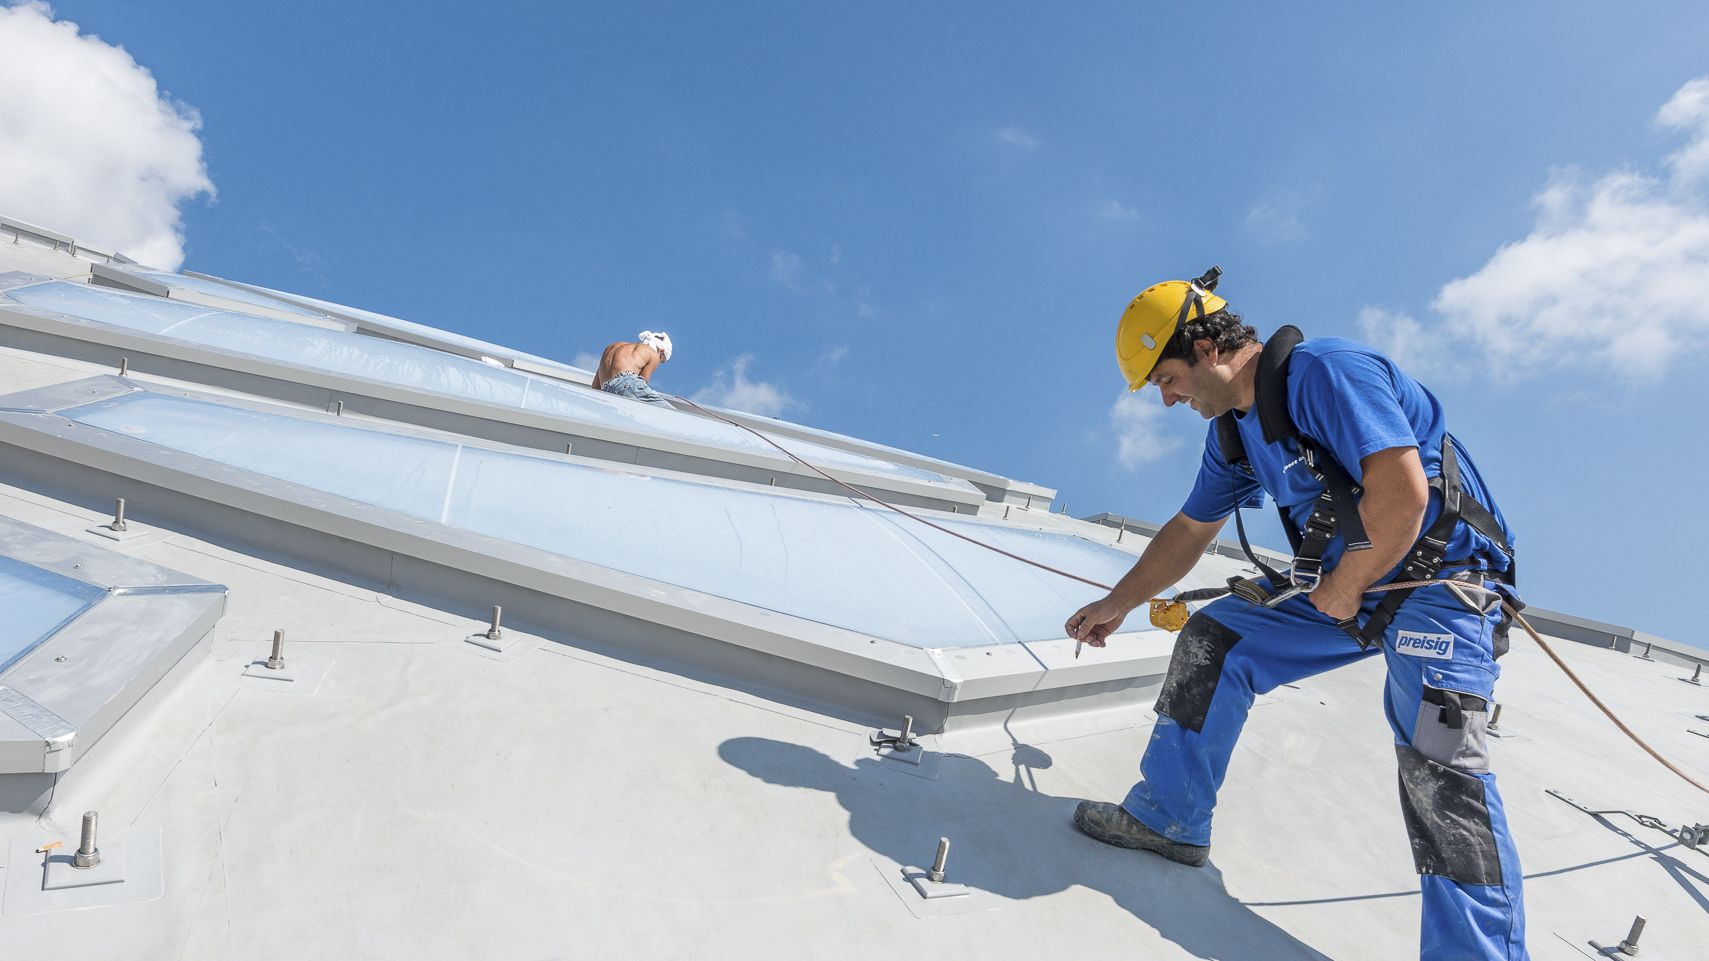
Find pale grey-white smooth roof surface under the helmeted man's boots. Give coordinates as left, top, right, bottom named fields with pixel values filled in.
left=0, top=230, right=1709, bottom=961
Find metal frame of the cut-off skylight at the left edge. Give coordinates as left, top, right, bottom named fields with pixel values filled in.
left=0, top=516, right=226, bottom=793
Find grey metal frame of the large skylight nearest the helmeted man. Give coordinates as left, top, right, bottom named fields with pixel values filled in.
left=0, top=378, right=1174, bottom=730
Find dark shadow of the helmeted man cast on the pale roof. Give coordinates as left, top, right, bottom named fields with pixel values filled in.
left=718, top=737, right=1326, bottom=961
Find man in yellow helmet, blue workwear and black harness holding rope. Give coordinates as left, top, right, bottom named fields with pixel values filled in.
left=1066, top=268, right=1528, bottom=961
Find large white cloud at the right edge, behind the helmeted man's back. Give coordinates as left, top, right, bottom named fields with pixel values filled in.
left=1360, top=77, right=1709, bottom=381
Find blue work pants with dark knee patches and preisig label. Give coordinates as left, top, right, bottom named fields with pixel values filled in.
left=1123, top=581, right=1528, bottom=961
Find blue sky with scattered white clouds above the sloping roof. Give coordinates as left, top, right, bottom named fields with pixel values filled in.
left=10, top=0, right=1709, bottom=645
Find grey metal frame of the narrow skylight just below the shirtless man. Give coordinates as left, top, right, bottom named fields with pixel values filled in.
left=0, top=274, right=984, bottom=513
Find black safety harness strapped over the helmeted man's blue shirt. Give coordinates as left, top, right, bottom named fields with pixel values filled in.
left=1209, top=327, right=1514, bottom=648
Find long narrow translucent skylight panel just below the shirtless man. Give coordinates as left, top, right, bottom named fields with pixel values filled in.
left=3, top=280, right=952, bottom=484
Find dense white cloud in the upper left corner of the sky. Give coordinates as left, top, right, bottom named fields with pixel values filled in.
left=0, top=0, right=214, bottom=270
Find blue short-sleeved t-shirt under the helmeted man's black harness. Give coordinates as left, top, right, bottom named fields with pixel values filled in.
left=1181, top=337, right=1514, bottom=580
